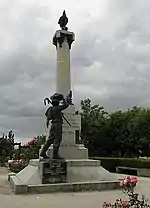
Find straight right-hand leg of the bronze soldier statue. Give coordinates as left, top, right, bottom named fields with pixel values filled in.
left=53, top=122, right=63, bottom=159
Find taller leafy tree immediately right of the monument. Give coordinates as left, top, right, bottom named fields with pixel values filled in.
left=80, top=99, right=111, bottom=155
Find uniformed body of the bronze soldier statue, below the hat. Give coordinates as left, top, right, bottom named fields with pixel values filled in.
left=40, top=95, right=69, bottom=159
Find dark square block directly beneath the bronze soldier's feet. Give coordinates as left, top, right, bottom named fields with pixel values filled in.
left=38, top=160, right=67, bottom=184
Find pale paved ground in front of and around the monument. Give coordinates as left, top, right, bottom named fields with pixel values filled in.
left=0, top=169, right=150, bottom=208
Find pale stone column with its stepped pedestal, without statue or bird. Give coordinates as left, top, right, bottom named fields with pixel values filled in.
left=43, top=30, right=88, bottom=159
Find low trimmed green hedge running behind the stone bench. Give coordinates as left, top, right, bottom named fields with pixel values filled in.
left=91, top=157, right=150, bottom=172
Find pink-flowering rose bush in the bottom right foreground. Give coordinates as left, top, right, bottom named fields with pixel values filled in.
left=103, top=176, right=150, bottom=208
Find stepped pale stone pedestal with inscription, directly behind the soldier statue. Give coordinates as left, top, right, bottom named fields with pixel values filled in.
left=39, top=106, right=88, bottom=159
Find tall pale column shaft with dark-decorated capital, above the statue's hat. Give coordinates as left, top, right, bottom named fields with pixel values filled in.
left=53, top=30, right=74, bottom=97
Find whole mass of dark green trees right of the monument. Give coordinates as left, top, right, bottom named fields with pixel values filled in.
left=81, top=99, right=150, bottom=157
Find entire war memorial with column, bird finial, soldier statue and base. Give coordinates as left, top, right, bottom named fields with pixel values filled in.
left=9, top=11, right=118, bottom=194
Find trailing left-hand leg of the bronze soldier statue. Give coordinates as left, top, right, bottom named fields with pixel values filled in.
left=40, top=124, right=55, bottom=159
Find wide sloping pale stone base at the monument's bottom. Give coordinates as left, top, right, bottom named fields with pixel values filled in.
left=9, top=159, right=119, bottom=194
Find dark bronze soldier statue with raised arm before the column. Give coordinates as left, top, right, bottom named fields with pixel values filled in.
left=40, top=93, right=70, bottom=159
